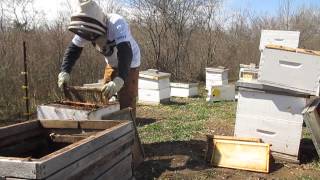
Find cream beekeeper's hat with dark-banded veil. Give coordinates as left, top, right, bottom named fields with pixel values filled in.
left=68, top=0, right=106, bottom=41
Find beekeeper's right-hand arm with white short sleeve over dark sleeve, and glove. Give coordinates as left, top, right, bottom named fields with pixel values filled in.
left=102, top=19, right=133, bottom=98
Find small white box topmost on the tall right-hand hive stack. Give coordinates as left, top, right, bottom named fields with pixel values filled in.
left=259, top=30, right=300, bottom=50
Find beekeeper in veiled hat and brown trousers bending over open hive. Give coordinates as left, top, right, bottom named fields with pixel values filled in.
left=58, top=0, right=140, bottom=115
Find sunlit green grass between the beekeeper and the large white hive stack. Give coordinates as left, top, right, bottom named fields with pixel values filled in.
left=139, top=95, right=236, bottom=143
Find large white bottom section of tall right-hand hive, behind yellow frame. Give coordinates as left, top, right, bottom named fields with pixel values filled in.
left=234, top=81, right=307, bottom=160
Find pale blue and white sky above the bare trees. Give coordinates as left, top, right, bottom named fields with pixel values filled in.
left=35, top=0, right=320, bottom=20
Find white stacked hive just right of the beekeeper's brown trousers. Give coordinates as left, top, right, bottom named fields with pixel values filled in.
left=138, top=69, right=170, bottom=104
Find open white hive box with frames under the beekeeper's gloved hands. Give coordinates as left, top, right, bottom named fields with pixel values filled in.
left=37, top=101, right=120, bottom=120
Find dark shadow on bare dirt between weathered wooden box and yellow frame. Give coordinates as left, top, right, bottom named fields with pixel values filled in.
left=135, top=140, right=210, bottom=179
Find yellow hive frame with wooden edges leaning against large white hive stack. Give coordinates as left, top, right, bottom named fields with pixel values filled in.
left=211, top=139, right=270, bottom=173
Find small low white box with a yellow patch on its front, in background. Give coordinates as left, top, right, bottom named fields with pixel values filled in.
left=206, top=84, right=236, bottom=102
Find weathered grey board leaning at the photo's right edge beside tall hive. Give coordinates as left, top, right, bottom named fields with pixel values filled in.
left=303, top=98, right=320, bottom=157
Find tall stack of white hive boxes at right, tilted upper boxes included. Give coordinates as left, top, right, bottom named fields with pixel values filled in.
left=235, top=31, right=320, bottom=162
